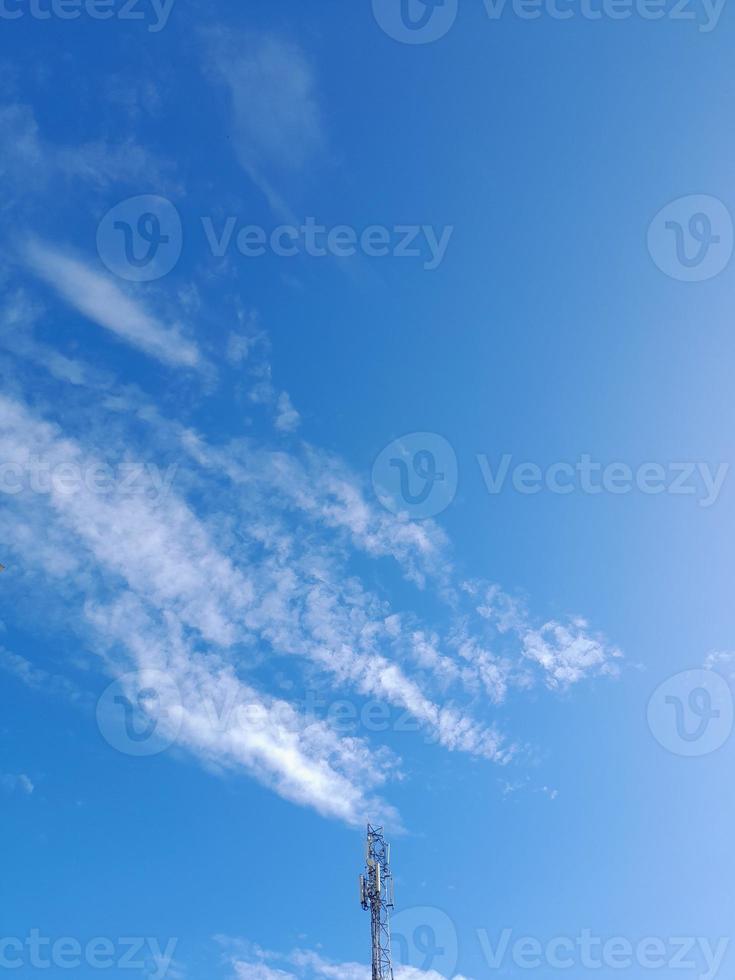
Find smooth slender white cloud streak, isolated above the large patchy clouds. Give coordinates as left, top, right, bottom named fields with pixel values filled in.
left=24, top=239, right=204, bottom=369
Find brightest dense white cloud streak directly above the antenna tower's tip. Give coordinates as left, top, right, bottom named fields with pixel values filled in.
left=86, top=592, right=399, bottom=824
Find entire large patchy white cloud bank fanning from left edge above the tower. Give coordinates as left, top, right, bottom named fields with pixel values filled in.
left=0, top=286, right=619, bottom=825
